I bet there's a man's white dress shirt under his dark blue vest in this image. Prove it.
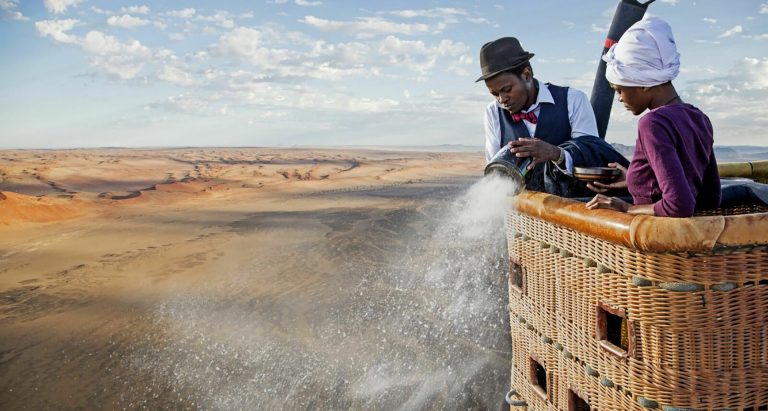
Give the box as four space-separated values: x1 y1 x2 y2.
485 82 598 174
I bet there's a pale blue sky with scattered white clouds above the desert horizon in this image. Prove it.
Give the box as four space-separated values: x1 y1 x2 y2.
0 0 768 149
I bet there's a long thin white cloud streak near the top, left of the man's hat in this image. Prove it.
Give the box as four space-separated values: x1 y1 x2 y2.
299 16 433 38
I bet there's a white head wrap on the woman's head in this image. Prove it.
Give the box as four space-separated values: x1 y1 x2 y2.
603 17 680 87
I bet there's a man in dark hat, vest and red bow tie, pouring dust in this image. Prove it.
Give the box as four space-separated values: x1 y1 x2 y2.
477 37 629 197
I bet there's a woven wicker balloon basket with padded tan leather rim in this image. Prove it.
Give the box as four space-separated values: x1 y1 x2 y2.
507 192 768 410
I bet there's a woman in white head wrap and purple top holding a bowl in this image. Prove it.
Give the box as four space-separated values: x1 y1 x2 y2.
587 17 720 217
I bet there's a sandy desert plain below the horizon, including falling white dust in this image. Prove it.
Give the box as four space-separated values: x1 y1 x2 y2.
0 148 509 409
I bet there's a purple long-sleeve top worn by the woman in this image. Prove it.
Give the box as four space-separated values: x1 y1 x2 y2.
627 104 720 217
